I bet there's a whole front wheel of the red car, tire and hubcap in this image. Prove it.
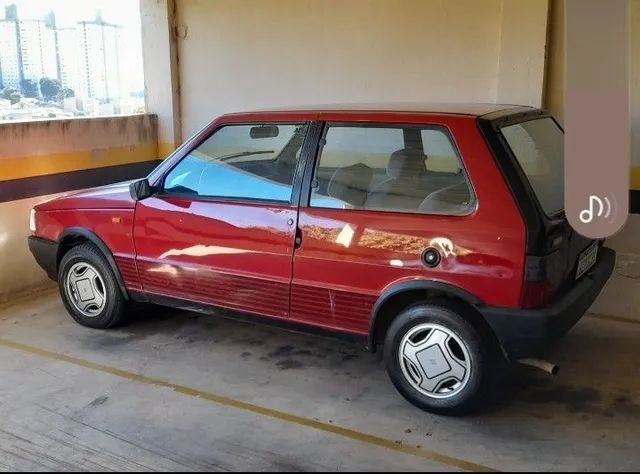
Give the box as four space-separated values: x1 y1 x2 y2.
58 244 126 329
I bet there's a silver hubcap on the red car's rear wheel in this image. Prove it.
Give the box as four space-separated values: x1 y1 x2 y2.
398 323 471 399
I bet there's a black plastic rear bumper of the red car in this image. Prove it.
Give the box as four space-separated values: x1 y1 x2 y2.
479 247 616 359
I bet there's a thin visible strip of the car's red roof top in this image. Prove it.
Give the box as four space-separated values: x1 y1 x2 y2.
244 102 535 117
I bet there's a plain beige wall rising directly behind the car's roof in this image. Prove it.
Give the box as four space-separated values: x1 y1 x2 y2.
175 0 547 137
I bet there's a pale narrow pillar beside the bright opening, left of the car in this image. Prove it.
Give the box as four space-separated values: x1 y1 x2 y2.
140 0 182 158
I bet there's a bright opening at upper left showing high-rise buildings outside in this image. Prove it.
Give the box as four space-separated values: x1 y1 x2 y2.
0 0 144 122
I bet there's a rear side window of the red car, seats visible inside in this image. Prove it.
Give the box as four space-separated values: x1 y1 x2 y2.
310 124 475 215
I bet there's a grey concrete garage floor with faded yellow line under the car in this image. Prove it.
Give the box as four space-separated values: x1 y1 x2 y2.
0 293 640 471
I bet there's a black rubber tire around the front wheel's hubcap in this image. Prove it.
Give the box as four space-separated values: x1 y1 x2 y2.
58 243 126 329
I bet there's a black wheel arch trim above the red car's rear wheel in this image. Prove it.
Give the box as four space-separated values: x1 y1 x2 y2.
367 280 484 352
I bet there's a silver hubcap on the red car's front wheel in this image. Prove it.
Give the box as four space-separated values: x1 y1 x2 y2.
65 262 107 318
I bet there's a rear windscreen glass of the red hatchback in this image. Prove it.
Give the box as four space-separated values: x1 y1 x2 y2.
501 117 564 216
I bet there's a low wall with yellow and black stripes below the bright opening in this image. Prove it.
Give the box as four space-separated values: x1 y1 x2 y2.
0 115 158 303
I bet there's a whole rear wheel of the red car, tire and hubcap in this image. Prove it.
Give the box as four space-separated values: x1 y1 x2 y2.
384 300 499 414
